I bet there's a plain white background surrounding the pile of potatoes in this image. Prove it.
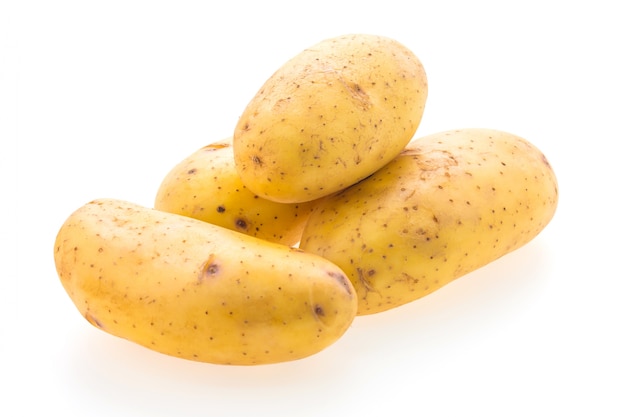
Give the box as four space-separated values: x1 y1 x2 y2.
0 0 626 417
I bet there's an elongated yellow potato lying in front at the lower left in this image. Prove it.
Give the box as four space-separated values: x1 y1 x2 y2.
54 199 357 365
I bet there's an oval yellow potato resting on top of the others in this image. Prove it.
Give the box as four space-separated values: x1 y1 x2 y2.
233 34 428 203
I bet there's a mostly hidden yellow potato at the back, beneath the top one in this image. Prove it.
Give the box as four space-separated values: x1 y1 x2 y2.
154 138 313 246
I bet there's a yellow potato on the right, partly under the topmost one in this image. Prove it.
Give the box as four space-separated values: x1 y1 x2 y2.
300 129 558 315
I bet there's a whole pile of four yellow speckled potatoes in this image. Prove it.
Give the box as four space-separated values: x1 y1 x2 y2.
54 34 558 365
